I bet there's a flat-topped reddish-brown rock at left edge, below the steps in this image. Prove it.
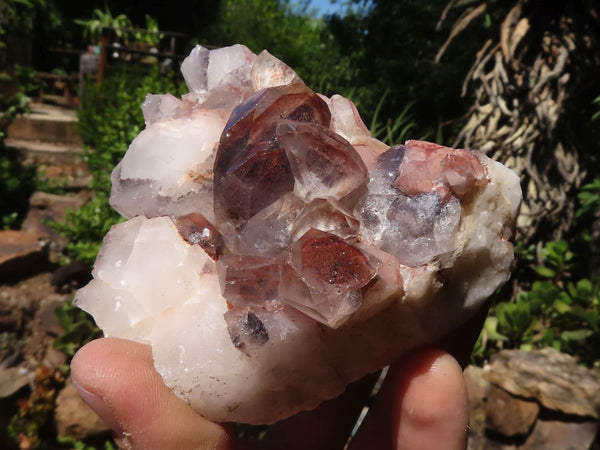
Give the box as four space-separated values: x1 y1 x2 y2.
0 230 48 278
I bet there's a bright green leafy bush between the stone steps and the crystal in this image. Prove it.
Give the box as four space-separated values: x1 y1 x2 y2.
52 68 183 264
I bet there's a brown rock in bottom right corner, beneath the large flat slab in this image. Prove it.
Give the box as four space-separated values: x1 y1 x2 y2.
518 420 598 450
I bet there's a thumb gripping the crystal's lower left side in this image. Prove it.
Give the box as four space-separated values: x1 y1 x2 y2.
71 338 234 450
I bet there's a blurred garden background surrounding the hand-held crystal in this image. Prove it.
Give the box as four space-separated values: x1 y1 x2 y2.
0 0 600 449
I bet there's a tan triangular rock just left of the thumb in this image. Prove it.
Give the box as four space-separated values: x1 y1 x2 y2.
54 379 110 440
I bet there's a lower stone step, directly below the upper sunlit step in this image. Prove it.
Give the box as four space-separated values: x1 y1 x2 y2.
4 139 91 189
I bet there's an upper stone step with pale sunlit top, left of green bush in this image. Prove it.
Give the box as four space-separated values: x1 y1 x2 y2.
7 103 81 145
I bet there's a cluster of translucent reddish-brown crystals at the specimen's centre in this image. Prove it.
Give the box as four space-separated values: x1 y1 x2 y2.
214 84 377 330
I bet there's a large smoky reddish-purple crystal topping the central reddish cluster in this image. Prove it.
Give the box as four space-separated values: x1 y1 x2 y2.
214 84 340 223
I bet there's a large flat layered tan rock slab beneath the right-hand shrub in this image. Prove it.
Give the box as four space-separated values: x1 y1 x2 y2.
487 348 600 419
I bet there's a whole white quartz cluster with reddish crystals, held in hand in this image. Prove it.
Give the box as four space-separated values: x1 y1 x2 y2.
75 45 521 424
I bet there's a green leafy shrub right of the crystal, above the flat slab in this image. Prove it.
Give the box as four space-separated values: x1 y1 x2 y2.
473 179 600 366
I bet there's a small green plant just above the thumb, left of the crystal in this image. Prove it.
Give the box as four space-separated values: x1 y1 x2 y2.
54 301 100 359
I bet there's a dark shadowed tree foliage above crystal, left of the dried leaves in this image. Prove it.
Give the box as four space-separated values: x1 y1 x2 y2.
327 0 486 137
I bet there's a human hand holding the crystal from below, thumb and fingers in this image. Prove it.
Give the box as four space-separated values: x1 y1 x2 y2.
71 338 468 450
